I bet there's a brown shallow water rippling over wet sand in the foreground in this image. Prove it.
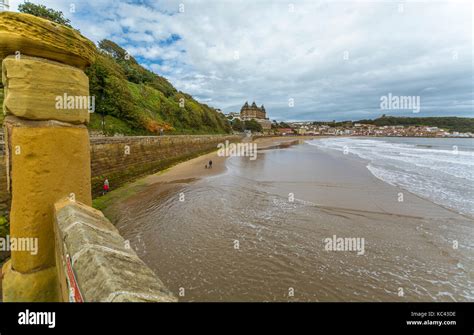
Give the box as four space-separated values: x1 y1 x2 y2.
116 144 474 301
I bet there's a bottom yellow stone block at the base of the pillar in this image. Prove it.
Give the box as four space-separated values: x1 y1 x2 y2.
2 261 59 302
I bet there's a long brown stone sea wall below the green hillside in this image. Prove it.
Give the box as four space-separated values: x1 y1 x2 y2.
0 135 241 215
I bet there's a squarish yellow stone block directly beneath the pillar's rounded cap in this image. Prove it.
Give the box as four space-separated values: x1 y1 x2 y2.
2 56 92 123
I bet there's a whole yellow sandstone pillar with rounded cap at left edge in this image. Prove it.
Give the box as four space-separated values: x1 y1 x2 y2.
0 12 94 301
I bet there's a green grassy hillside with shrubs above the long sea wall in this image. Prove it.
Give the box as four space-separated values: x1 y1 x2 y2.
86 40 231 135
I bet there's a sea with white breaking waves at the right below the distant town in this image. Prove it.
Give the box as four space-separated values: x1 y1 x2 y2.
307 137 474 217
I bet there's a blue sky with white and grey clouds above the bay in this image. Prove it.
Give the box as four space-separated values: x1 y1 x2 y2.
10 0 474 120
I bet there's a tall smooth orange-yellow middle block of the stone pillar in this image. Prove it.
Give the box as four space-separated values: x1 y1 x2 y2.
4 116 92 272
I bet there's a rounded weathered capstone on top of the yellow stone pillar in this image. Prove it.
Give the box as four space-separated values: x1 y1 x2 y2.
0 12 96 69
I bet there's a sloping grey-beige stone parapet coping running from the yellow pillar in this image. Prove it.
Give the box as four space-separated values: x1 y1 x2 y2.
54 199 177 302
